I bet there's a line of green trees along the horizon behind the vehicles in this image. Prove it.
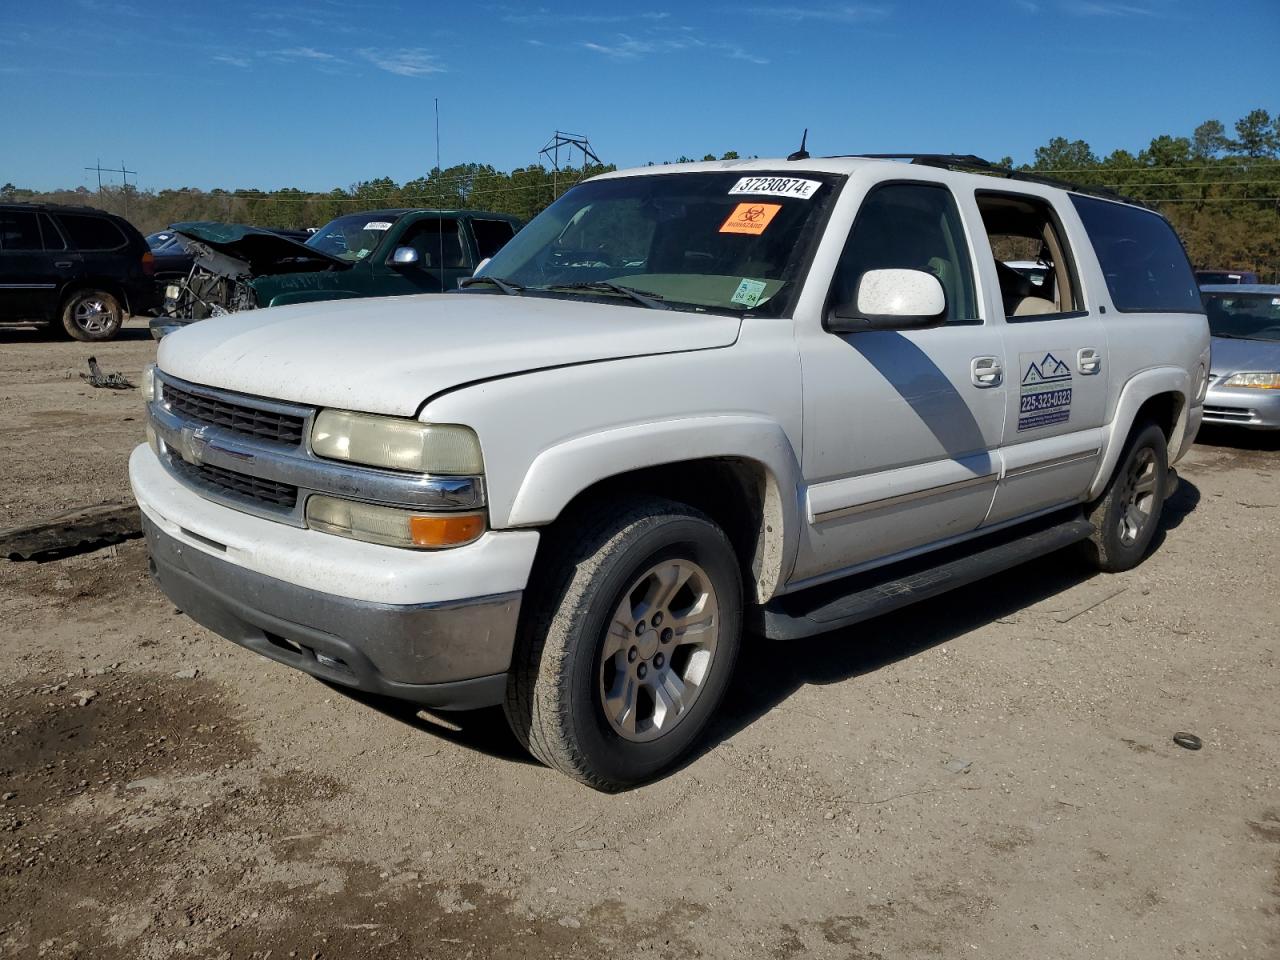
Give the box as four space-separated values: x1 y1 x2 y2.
0 109 1280 282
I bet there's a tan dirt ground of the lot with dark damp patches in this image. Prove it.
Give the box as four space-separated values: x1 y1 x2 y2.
0 324 1280 960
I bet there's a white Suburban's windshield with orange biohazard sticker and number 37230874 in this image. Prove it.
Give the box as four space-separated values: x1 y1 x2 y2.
470 173 842 316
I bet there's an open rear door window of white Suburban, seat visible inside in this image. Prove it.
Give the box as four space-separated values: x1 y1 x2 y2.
975 192 1084 321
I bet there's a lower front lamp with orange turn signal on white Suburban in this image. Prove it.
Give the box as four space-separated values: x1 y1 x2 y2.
307 495 485 549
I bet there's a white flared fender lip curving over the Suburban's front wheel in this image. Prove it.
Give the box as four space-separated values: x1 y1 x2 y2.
502 416 801 599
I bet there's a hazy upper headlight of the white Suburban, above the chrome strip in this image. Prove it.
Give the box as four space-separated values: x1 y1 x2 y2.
311 410 484 476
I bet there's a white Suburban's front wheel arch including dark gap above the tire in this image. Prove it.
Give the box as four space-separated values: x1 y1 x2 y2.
506 417 800 603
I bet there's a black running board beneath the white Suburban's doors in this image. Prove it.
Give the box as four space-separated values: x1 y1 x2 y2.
758 509 1093 640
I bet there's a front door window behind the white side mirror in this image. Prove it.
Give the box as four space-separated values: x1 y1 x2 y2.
836 183 978 323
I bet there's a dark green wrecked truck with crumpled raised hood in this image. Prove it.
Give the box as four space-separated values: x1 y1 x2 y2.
151 209 521 340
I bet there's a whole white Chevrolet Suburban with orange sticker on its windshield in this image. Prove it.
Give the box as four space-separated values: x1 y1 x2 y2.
129 155 1210 790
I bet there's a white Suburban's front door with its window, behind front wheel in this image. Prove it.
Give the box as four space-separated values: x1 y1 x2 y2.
792 182 1006 581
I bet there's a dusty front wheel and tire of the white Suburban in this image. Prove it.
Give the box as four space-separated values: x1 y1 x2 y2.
504 498 742 791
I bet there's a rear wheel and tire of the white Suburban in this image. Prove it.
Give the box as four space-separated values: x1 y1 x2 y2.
1083 422 1169 573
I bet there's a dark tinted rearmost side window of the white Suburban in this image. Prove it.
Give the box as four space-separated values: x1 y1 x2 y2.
1071 193 1204 314
